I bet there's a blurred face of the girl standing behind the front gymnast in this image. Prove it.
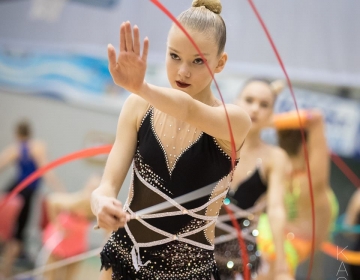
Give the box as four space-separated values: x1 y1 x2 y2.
237 81 274 130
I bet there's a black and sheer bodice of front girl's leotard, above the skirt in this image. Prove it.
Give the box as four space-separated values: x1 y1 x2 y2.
128 108 235 245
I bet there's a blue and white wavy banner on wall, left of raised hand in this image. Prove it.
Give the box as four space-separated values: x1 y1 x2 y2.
0 50 128 112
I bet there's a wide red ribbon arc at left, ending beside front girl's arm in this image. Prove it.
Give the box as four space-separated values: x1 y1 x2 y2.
0 145 112 211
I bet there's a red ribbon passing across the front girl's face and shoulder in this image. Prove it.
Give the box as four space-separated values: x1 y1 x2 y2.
150 0 250 280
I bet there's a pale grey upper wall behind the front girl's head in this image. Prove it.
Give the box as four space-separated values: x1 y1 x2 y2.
0 0 360 86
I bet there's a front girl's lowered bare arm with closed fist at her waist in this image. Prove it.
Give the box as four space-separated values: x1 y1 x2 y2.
91 95 148 231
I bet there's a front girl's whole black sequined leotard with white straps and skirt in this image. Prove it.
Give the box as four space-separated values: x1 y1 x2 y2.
100 107 238 279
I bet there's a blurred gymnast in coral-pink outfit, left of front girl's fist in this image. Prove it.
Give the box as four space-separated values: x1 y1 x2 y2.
43 175 101 280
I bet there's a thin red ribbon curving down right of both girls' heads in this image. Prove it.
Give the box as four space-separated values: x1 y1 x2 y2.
248 0 315 279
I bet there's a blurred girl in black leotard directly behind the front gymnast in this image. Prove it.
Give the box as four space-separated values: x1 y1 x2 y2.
215 79 293 280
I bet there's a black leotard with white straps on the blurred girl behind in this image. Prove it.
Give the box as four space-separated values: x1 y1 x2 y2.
215 168 267 280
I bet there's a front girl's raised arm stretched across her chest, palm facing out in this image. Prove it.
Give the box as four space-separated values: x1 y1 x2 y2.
108 22 251 148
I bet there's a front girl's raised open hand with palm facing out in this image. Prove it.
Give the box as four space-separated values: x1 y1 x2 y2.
108 21 149 94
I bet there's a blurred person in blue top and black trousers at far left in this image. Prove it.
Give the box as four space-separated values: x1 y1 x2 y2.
0 120 64 277
